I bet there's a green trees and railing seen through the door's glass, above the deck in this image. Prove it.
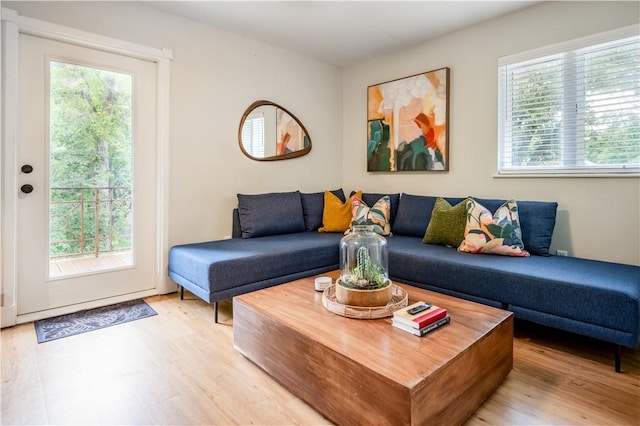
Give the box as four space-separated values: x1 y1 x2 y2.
49 61 132 256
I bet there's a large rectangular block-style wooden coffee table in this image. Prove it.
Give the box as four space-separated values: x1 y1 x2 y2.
233 271 513 425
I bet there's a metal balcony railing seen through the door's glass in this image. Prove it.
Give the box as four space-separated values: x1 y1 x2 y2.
49 187 133 259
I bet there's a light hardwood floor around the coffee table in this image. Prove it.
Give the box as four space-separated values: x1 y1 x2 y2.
0 293 640 425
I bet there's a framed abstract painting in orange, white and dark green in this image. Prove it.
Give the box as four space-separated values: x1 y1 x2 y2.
367 67 450 172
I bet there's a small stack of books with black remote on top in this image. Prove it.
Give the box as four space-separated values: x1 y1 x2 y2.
391 302 451 336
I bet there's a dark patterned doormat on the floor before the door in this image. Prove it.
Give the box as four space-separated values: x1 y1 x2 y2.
34 299 158 343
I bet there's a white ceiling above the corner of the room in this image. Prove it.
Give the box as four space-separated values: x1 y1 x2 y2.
148 0 540 67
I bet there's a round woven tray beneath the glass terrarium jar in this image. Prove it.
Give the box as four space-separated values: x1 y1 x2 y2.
322 284 409 319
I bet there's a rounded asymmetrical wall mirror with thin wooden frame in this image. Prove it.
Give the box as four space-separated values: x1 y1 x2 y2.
238 101 311 161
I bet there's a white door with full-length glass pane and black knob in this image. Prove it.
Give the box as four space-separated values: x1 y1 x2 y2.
16 34 157 317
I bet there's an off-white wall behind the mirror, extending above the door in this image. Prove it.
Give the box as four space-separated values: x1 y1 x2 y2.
3 2 342 245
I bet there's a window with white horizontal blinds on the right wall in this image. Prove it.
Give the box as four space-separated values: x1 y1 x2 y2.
498 26 640 175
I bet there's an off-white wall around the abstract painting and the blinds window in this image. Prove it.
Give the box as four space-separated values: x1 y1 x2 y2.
342 2 640 265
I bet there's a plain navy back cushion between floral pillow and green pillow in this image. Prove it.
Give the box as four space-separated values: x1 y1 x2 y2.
391 194 437 238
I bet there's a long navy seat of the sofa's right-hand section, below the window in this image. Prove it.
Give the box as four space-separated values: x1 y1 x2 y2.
387 236 640 347
